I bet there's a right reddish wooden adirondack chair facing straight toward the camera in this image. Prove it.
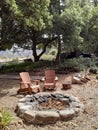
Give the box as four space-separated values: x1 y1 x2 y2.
42 70 58 90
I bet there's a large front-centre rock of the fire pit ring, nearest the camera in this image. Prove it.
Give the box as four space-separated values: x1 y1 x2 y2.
35 111 60 124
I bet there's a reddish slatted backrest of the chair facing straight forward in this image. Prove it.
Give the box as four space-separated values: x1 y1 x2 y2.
45 70 55 83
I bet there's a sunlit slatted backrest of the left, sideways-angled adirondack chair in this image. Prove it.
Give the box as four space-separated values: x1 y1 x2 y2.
20 72 31 87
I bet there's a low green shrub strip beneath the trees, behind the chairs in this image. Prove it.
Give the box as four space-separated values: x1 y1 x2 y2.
0 55 98 73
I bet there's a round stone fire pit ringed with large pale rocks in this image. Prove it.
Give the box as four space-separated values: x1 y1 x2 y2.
15 93 84 124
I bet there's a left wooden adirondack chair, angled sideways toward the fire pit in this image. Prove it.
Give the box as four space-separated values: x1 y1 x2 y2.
17 72 40 94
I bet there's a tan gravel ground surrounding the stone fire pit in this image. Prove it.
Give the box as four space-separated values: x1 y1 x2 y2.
0 74 98 130
